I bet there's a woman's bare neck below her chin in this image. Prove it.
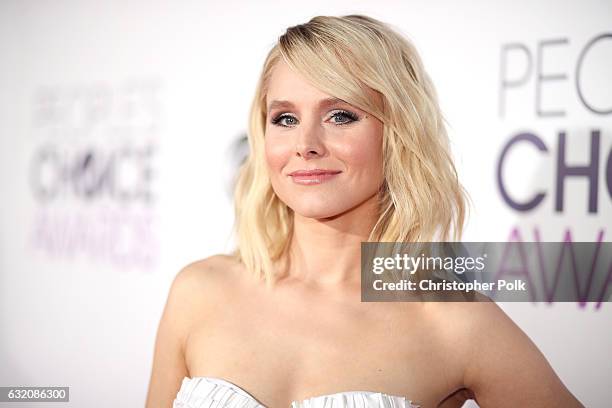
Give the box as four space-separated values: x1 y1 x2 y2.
280 195 378 288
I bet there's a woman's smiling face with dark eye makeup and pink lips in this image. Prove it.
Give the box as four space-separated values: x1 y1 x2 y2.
265 61 383 219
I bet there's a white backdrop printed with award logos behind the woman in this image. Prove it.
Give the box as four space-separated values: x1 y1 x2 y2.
0 0 612 407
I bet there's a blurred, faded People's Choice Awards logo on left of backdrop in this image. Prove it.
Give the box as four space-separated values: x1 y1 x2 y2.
27 78 162 271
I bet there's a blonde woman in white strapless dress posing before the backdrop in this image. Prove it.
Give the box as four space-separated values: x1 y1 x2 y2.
147 15 581 408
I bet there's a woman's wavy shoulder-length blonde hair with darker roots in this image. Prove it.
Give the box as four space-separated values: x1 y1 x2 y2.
232 15 468 283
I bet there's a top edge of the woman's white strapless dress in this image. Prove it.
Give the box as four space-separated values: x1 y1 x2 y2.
172 377 420 408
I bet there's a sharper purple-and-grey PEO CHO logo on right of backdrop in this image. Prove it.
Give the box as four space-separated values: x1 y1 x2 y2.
496 32 612 306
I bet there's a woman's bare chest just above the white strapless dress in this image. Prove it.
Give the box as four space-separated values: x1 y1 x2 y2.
185 304 461 407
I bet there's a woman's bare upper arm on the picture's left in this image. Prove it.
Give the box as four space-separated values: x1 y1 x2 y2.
146 264 207 408
